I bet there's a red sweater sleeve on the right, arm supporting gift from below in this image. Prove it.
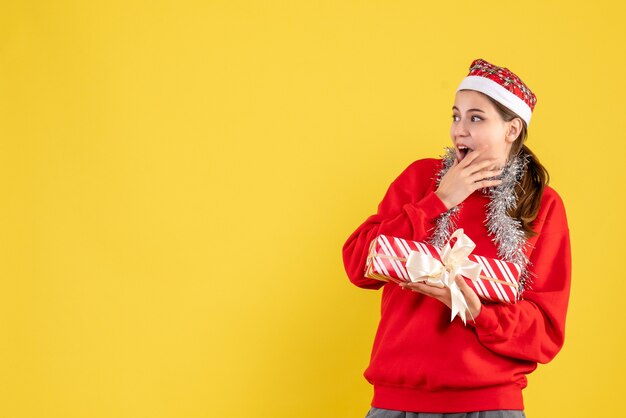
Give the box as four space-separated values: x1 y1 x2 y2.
468 191 571 363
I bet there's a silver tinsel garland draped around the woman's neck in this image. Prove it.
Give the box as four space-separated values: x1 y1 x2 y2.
429 148 530 296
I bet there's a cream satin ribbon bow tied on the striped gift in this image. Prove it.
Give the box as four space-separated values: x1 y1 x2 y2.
406 228 481 324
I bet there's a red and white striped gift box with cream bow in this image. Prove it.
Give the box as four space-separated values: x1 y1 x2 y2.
365 229 521 304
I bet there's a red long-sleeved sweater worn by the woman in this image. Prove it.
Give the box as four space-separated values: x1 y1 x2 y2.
343 159 571 413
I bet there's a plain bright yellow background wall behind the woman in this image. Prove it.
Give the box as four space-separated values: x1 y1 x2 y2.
0 0 626 418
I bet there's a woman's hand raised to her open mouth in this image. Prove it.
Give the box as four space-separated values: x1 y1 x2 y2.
435 151 502 209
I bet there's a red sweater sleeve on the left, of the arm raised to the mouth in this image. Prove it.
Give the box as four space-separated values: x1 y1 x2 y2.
342 159 447 289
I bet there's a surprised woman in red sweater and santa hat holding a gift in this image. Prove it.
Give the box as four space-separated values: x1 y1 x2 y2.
343 59 571 418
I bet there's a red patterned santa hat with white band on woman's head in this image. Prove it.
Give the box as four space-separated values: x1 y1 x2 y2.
457 59 537 126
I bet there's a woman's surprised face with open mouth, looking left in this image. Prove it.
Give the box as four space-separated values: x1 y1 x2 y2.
450 90 519 168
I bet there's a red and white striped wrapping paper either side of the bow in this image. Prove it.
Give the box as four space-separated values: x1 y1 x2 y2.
365 235 521 304
